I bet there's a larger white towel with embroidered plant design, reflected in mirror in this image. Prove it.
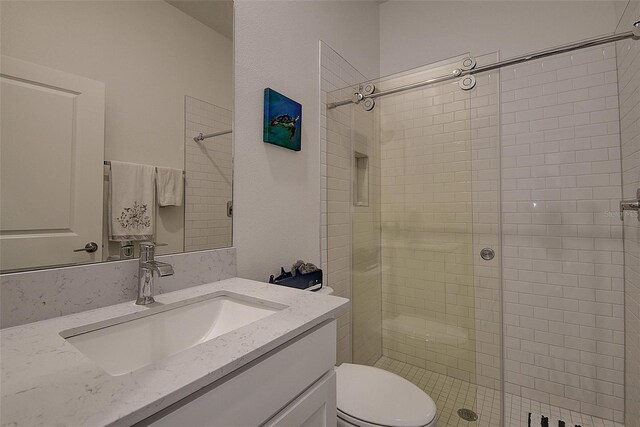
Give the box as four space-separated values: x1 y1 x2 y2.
109 161 156 241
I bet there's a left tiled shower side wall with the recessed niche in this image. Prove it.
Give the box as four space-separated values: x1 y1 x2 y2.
320 42 382 364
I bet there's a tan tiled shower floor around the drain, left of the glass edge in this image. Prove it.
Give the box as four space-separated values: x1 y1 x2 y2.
375 356 500 427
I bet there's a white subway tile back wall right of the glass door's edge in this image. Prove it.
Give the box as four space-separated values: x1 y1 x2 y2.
501 44 624 421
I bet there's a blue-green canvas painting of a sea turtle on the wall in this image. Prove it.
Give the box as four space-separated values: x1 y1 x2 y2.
263 88 302 151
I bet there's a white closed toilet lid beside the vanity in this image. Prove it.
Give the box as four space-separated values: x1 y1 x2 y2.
336 363 436 427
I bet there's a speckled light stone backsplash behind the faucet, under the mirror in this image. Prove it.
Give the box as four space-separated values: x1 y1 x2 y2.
0 248 236 328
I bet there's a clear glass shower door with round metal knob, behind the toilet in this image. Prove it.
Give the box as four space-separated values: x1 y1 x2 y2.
327 55 502 426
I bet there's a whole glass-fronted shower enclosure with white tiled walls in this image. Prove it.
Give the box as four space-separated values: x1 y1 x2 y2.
326 9 640 427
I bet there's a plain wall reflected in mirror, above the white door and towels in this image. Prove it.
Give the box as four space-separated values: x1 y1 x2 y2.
1 0 233 253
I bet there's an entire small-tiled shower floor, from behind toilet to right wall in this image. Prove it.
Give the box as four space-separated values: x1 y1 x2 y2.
375 356 624 427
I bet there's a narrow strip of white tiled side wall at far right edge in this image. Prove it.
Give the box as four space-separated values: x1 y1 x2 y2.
616 0 640 427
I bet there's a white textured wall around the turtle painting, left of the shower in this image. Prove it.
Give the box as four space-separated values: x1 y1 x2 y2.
233 0 379 280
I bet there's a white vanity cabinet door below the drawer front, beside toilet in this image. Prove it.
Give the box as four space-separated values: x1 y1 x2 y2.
266 370 338 427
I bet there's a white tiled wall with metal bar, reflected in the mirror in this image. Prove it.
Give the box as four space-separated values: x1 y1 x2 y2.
184 96 233 251
